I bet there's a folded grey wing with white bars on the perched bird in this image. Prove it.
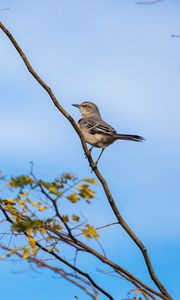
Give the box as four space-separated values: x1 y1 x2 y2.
79 117 116 136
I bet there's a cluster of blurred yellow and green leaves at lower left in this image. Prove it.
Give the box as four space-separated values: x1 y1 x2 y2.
0 172 99 259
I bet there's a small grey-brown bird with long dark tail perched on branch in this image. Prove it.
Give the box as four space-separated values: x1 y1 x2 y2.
72 101 145 165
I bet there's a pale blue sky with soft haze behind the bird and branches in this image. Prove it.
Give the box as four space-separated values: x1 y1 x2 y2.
0 0 180 300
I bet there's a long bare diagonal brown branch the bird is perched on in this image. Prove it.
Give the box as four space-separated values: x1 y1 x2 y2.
0 22 172 299
